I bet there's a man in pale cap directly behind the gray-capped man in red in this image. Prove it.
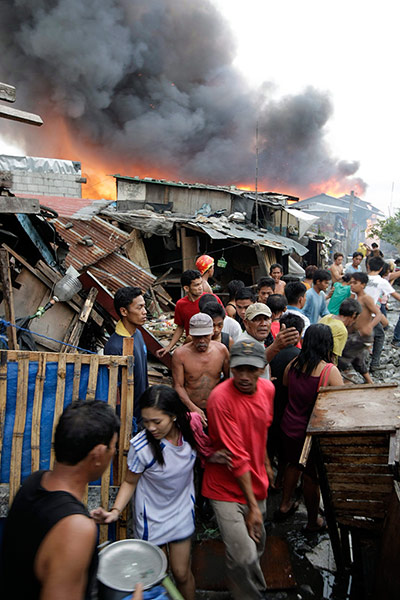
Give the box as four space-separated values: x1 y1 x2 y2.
238 302 299 379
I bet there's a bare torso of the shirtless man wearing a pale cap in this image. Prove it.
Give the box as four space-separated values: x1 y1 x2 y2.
172 341 229 422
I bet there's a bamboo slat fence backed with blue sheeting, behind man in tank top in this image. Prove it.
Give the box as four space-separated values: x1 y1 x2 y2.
0 350 134 542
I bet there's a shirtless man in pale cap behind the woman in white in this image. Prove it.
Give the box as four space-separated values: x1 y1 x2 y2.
172 313 229 426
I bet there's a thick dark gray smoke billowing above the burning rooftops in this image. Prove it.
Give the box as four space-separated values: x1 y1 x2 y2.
0 0 363 194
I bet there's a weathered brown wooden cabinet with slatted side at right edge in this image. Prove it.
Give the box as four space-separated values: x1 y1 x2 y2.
303 385 400 569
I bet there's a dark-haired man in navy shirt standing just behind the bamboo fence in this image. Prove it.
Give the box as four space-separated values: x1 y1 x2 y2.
104 287 149 433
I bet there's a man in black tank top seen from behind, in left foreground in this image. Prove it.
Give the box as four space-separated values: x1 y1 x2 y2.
0 401 142 600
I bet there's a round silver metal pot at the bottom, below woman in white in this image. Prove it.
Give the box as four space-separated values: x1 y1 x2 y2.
97 540 168 600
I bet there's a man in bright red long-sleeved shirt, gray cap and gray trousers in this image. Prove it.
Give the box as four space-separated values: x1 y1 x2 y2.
202 338 274 600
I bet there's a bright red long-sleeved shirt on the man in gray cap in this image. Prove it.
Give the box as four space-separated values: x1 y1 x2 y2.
202 378 275 504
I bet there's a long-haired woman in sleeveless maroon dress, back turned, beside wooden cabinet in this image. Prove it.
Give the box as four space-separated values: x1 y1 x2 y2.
275 324 343 532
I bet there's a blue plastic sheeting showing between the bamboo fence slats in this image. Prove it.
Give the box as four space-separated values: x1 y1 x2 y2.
0 362 108 483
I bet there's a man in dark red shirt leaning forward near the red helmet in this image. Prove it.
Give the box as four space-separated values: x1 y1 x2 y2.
156 269 222 358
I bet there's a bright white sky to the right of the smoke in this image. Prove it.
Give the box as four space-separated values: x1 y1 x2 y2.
215 0 400 214
